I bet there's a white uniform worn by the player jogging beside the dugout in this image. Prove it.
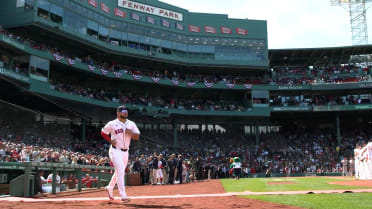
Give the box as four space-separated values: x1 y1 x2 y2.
102 119 140 199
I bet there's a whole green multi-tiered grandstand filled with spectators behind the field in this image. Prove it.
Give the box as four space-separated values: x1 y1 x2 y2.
0 0 372 197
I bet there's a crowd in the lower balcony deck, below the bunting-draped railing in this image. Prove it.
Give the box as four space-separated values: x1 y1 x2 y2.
51 77 372 112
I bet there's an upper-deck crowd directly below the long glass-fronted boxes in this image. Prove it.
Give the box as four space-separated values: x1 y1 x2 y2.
0 29 261 84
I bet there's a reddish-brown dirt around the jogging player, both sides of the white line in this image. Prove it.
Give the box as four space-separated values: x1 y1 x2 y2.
0 180 298 209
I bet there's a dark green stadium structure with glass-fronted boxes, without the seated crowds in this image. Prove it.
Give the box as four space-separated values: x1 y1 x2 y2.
0 0 372 145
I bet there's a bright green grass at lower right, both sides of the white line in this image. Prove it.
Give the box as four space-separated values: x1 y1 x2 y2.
221 177 372 209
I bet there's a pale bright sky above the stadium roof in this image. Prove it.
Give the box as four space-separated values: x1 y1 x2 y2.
160 0 372 49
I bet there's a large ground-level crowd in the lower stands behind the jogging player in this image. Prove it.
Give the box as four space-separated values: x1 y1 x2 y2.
0 117 372 184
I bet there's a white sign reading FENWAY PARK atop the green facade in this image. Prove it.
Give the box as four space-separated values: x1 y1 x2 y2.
118 0 183 21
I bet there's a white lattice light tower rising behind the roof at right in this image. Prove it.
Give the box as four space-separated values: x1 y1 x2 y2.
331 0 372 45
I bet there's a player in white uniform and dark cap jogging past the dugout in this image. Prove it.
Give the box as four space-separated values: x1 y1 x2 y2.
101 105 140 203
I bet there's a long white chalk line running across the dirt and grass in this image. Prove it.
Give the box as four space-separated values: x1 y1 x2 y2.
0 189 372 202
